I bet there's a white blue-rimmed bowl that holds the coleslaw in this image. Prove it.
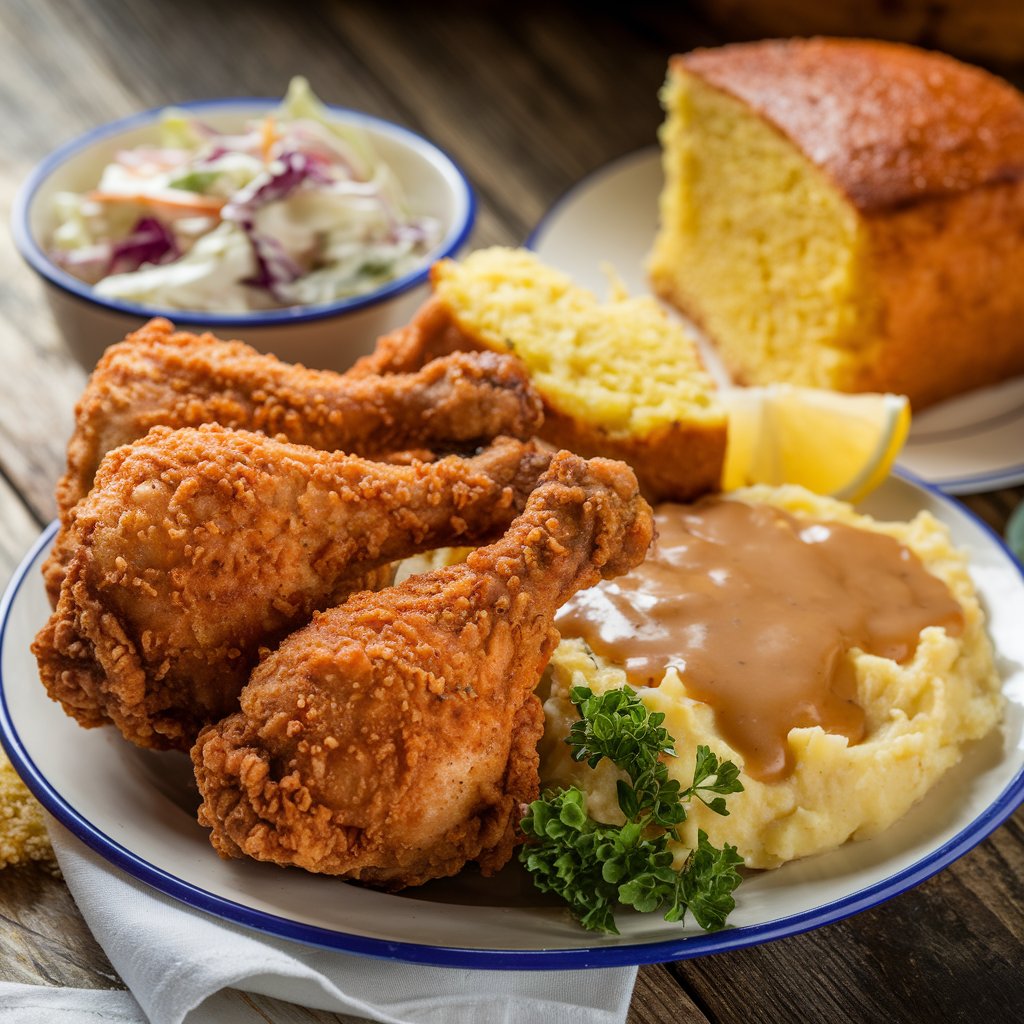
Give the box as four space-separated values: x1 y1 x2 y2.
11 97 476 370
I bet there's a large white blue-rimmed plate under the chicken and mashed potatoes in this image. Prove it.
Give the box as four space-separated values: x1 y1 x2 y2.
0 478 1024 969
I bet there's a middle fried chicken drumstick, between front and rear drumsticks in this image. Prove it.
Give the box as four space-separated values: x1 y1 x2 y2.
33 425 551 750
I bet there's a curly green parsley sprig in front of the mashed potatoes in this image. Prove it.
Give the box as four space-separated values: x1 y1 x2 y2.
519 686 743 935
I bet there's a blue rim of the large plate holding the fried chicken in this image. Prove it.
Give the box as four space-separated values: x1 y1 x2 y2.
0 472 1024 971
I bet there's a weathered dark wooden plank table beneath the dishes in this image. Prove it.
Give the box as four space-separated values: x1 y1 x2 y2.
0 0 1024 1024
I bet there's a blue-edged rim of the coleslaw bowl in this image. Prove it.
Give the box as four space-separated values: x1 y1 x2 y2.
11 96 477 328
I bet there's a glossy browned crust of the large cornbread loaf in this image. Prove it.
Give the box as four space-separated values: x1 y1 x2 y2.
659 39 1024 409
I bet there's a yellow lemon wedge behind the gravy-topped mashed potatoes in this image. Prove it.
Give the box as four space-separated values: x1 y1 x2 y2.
720 384 910 502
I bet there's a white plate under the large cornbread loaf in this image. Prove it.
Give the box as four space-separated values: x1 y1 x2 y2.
526 146 1024 495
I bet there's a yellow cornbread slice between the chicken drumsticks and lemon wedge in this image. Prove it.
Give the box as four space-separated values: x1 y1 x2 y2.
431 248 726 501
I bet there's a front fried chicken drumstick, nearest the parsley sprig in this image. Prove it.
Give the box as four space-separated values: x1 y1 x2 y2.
193 452 653 889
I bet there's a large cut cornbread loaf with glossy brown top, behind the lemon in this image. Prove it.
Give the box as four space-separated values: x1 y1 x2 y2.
649 39 1024 409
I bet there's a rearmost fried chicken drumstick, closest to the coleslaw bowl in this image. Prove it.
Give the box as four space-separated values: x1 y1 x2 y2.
43 319 541 604
